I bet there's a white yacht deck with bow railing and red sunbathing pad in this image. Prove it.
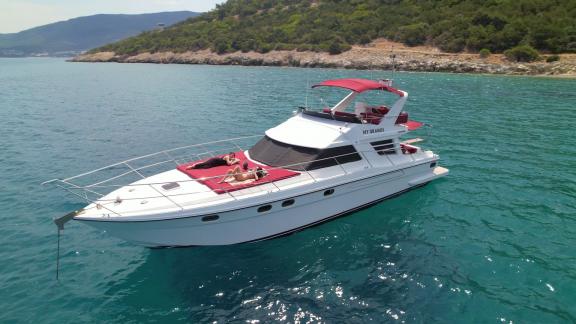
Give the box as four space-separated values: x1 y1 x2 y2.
49 134 434 220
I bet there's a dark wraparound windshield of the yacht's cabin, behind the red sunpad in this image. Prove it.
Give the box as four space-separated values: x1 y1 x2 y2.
249 136 362 171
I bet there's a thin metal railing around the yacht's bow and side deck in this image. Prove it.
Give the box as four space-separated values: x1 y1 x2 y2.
42 135 426 215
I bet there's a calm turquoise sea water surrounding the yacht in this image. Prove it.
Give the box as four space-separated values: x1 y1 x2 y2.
0 59 576 323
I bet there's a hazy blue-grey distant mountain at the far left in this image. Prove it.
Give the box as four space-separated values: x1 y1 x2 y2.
0 11 199 57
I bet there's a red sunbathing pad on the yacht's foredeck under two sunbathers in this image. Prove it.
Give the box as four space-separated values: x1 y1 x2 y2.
176 151 300 194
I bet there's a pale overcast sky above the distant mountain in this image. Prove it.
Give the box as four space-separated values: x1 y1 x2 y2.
0 0 226 33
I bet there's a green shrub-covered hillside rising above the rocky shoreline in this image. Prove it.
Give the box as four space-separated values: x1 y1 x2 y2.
93 0 576 55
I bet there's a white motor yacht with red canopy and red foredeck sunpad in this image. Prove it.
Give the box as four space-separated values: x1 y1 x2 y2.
45 79 448 247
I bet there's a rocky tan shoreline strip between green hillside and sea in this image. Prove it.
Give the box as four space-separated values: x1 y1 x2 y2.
70 40 576 78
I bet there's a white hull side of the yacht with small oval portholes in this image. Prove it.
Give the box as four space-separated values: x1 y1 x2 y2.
76 163 447 247
